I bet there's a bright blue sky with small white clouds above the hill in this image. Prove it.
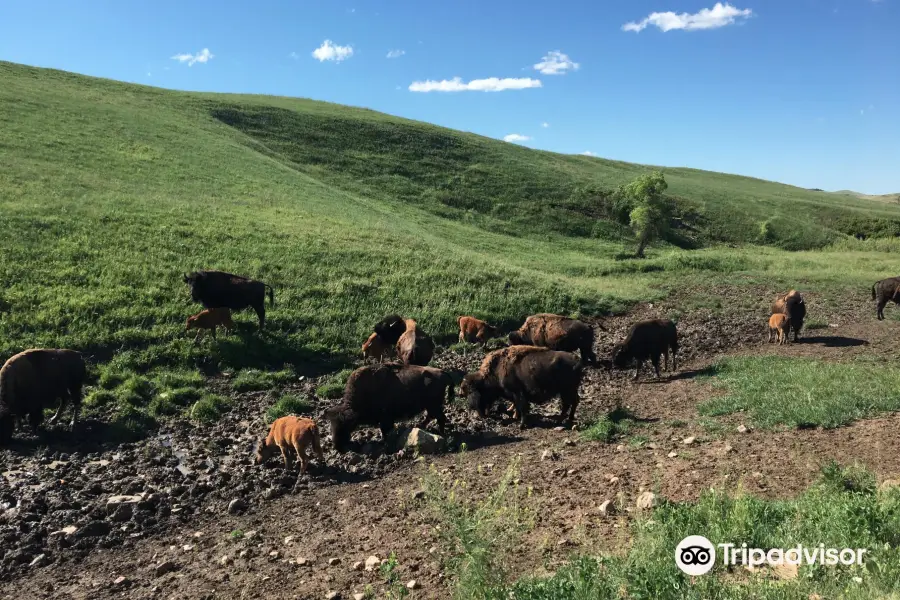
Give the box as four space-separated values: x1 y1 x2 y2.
0 0 900 194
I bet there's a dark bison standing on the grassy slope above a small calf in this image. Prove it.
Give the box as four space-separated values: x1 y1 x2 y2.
184 271 275 329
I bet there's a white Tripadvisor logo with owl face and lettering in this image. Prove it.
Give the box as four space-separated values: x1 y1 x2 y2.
675 535 867 576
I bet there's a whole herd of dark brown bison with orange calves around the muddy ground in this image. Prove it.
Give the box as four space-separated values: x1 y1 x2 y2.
0 271 900 471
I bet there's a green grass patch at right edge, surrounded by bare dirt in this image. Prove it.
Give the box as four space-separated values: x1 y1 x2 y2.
698 356 900 428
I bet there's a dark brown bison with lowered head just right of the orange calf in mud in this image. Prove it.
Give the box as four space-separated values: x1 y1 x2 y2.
324 363 453 452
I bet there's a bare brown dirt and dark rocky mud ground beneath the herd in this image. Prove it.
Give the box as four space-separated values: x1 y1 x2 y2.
0 290 900 600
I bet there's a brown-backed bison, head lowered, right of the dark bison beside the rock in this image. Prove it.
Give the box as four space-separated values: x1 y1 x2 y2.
460 346 583 429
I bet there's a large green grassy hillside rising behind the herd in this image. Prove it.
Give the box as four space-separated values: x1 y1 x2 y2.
0 63 900 426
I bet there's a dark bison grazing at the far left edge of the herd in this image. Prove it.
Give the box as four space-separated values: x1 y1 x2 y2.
0 348 87 444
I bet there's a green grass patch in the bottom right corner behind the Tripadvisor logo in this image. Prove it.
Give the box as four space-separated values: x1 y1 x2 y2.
448 464 900 600
